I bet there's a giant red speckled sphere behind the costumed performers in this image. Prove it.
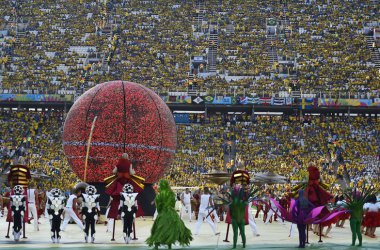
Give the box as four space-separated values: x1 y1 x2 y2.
63 81 177 183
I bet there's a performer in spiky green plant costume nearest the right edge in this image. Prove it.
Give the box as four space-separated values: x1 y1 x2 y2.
344 184 377 246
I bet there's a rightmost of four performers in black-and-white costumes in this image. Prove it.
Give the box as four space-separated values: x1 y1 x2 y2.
119 183 138 244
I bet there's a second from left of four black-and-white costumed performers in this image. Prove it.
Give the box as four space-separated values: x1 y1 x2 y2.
46 188 66 243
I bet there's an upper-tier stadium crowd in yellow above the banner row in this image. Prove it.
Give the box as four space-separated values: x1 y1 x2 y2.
0 0 380 96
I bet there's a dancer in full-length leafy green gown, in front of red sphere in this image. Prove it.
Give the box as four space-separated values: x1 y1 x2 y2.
146 180 193 249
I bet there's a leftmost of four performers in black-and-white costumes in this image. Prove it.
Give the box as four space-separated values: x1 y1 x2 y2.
10 185 26 241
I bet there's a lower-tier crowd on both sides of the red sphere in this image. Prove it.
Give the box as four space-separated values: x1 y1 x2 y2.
0 111 380 191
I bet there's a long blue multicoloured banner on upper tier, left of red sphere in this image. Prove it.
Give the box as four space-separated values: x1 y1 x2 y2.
0 94 74 102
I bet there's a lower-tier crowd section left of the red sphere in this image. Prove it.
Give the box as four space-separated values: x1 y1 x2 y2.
0 110 79 191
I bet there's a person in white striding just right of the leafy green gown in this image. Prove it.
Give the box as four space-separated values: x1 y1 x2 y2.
194 187 219 235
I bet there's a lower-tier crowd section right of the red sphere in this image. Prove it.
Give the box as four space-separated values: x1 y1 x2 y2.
169 115 380 192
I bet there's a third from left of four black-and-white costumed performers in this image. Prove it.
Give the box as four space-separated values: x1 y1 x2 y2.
82 185 100 243
